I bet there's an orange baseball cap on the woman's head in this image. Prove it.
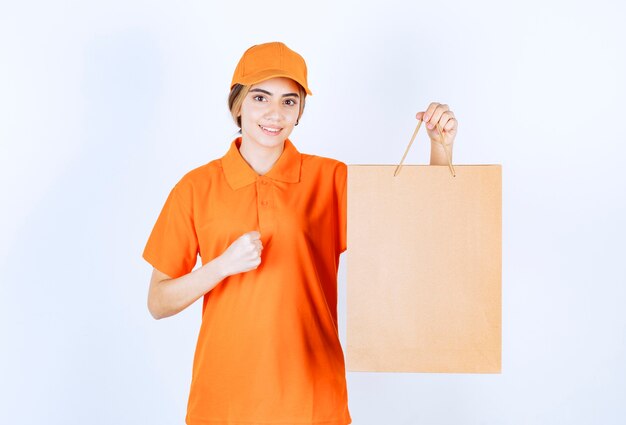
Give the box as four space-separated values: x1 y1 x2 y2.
230 41 313 95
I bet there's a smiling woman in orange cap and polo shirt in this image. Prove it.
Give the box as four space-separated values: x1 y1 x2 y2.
143 42 457 425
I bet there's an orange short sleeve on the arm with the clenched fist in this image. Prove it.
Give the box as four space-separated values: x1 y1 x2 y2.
143 182 198 278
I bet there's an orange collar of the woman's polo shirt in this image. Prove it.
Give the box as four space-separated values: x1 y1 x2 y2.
221 136 302 190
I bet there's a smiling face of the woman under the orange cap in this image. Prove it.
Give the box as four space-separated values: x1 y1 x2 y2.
240 77 300 148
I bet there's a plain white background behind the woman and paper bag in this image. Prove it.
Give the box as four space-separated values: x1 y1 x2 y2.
0 0 626 425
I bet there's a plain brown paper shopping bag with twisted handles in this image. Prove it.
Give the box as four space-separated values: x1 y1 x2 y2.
346 121 502 373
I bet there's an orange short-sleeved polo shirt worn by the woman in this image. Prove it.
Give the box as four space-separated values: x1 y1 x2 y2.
143 137 352 425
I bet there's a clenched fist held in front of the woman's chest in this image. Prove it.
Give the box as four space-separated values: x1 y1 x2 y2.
220 230 263 277
